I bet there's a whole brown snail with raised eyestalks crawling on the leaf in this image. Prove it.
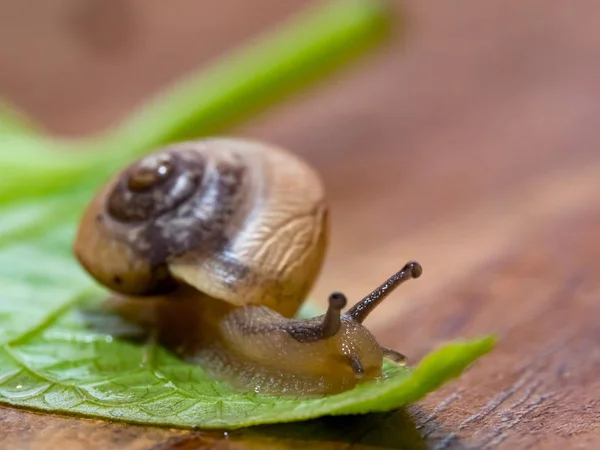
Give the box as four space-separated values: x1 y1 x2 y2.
74 139 422 395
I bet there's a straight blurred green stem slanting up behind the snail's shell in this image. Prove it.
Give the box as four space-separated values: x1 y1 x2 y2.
88 0 389 164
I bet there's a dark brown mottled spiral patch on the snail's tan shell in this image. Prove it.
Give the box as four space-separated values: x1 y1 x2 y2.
105 146 250 267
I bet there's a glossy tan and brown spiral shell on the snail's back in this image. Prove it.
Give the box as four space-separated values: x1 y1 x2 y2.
74 139 328 316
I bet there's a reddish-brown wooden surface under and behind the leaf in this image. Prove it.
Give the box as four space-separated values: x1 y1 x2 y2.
0 0 600 450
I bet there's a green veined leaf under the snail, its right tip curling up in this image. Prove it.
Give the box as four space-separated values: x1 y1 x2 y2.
0 227 493 428
